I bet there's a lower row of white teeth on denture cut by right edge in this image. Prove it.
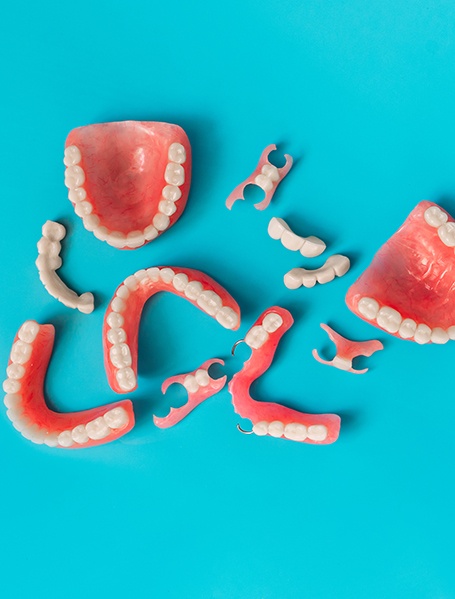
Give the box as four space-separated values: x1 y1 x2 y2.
357 297 455 345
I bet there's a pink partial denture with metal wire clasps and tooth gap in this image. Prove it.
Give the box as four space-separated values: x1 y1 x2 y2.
228 306 341 445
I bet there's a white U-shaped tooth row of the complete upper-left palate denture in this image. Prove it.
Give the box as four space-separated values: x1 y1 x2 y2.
63 143 186 249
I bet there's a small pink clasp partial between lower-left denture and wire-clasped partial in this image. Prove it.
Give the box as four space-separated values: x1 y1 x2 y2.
153 359 227 428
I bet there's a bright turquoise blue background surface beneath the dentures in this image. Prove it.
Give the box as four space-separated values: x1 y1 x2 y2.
0 0 455 599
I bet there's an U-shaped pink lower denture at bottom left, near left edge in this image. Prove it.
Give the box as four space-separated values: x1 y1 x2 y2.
3 320 134 449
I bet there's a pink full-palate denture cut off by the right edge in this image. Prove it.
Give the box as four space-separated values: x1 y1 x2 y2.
346 201 455 344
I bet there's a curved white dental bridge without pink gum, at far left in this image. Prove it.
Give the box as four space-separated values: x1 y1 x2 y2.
35 220 95 314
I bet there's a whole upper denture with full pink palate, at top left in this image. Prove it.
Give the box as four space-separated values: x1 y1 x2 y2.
64 121 191 249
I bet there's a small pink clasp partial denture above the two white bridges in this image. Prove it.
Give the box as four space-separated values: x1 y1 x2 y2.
226 144 292 210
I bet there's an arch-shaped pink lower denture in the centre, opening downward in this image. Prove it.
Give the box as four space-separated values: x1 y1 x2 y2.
103 266 240 393
